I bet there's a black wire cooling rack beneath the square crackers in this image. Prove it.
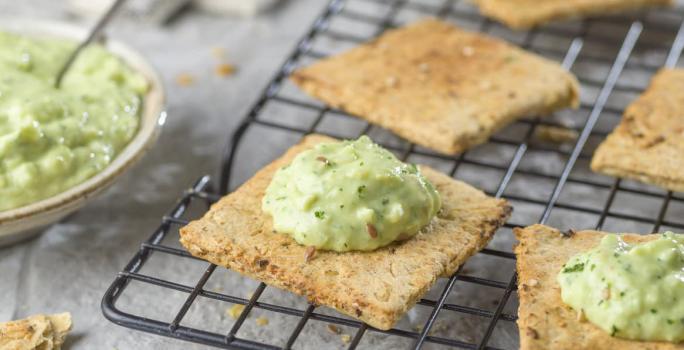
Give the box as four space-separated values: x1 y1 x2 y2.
102 0 684 349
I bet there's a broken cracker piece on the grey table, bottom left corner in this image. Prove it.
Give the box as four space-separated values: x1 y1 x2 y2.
0 312 71 350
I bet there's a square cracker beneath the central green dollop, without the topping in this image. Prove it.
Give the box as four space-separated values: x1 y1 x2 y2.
180 135 511 329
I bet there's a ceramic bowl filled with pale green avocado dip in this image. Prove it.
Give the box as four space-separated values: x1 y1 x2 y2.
0 20 166 246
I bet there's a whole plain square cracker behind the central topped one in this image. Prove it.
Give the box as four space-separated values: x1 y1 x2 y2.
291 19 579 154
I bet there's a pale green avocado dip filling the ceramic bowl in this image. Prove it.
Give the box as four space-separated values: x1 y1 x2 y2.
0 32 147 211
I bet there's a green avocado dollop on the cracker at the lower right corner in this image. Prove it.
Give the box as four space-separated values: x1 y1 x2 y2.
557 232 684 342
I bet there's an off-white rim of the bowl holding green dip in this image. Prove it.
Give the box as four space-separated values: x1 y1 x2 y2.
0 18 167 225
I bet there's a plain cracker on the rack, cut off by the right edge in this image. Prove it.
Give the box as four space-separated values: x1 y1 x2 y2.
591 69 684 191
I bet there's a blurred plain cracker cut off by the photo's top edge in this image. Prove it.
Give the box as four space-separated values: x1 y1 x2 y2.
474 0 672 29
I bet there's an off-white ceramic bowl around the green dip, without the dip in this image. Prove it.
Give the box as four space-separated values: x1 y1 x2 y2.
0 19 166 247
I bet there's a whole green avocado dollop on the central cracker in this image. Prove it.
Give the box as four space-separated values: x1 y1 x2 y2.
262 136 441 252
